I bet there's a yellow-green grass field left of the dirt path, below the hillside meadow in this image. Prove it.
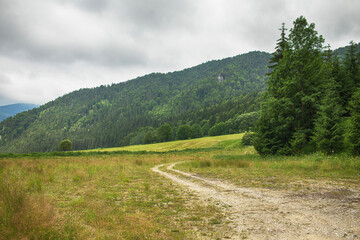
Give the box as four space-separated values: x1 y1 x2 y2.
0 155 228 239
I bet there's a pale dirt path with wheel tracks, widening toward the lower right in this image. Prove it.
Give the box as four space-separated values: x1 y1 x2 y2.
152 163 360 239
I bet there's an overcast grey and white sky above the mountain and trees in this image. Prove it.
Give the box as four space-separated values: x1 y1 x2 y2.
0 0 360 105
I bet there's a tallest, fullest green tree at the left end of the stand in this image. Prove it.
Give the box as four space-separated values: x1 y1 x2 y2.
254 16 324 154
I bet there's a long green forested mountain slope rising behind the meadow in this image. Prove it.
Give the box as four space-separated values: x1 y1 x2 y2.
0 52 271 152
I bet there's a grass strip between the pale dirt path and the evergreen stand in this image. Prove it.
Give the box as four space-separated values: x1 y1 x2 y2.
176 150 360 190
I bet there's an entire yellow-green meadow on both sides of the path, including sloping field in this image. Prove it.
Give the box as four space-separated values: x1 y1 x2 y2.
0 134 360 239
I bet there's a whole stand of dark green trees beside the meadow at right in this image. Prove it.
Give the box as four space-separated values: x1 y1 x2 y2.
254 17 360 155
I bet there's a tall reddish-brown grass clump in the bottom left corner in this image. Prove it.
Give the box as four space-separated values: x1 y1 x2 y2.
0 179 66 239
